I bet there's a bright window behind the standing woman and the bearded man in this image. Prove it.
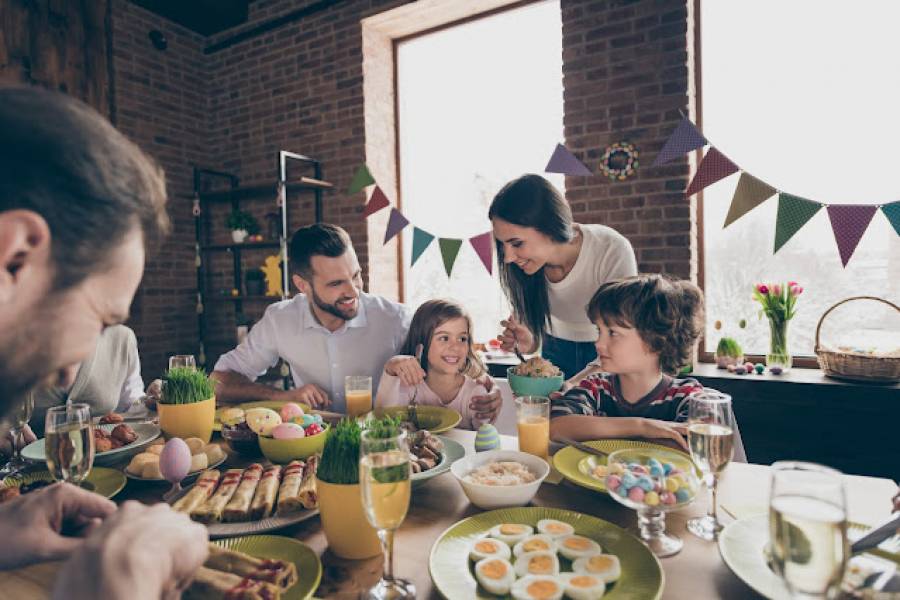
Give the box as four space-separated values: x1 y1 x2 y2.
397 0 563 342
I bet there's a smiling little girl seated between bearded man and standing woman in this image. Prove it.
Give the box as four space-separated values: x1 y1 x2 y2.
375 300 490 429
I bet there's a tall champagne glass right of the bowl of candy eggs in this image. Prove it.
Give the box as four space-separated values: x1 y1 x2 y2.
687 390 734 541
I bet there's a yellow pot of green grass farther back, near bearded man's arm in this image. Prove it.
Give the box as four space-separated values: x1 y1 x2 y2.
157 367 216 442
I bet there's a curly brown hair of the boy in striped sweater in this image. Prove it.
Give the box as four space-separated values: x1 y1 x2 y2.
587 275 703 374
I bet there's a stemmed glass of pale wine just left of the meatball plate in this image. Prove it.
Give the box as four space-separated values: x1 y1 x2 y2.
44 404 94 485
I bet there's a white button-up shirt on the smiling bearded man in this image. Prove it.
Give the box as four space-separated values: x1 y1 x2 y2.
215 293 412 412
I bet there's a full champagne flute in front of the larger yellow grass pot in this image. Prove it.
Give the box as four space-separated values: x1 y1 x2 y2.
359 431 416 600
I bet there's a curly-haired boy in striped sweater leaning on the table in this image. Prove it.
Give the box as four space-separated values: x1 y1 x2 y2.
550 275 703 449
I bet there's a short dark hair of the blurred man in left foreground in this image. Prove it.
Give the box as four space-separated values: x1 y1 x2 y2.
0 87 169 289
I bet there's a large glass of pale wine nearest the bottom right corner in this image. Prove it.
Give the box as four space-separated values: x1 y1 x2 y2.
769 461 850 598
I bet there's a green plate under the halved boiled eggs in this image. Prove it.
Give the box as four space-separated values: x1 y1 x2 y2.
429 507 665 600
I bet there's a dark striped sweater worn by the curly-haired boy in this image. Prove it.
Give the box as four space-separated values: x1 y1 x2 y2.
550 373 703 422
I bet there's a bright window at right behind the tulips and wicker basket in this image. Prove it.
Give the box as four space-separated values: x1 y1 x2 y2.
700 0 900 355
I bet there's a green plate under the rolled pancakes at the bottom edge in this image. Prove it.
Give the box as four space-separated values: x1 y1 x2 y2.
213 535 322 600
